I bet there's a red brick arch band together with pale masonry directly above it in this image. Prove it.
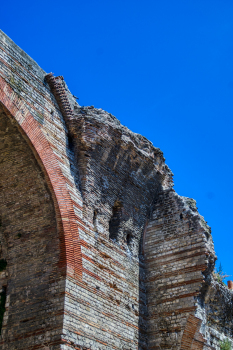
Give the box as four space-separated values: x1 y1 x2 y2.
0 32 82 282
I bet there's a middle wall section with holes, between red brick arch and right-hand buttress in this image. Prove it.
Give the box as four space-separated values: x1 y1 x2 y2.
46 74 172 349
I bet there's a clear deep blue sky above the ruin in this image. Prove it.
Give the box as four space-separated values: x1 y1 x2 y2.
1 0 233 278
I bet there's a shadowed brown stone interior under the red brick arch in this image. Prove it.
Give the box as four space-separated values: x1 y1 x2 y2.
0 106 64 349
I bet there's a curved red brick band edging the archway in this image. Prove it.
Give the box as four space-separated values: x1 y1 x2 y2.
0 77 82 279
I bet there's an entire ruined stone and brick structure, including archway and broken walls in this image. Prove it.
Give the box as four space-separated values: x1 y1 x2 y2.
0 31 233 350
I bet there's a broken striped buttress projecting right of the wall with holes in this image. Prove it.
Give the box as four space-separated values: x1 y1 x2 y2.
145 190 215 349
